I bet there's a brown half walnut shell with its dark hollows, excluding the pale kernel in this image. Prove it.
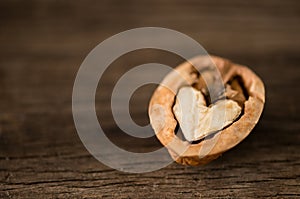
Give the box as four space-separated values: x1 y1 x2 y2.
148 56 265 166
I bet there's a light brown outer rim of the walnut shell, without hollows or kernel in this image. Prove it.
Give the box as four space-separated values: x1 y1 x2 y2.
148 56 265 166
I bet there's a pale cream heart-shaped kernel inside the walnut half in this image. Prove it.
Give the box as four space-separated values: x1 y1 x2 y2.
173 86 242 142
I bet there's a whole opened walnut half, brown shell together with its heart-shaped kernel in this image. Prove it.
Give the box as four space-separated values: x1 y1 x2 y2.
149 56 265 165
